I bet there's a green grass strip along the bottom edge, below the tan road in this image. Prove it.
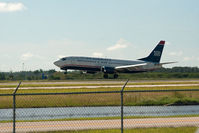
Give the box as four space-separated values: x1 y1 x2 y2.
36 127 197 133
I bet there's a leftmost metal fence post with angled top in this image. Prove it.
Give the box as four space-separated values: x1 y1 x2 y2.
13 81 21 133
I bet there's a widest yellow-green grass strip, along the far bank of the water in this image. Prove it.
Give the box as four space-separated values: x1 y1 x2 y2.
0 90 199 108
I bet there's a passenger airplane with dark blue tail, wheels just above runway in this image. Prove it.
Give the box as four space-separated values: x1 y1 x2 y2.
54 41 175 78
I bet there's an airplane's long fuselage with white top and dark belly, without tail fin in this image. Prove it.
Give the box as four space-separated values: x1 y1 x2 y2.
54 56 160 73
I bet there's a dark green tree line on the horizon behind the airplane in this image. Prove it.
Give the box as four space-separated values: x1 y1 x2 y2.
0 67 199 80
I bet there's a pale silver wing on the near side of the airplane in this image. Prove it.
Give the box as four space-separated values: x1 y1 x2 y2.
115 63 147 71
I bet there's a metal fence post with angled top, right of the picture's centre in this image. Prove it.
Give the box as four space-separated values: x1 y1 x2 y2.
120 79 129 133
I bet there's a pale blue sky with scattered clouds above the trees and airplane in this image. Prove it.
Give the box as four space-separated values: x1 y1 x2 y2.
0 0 199 72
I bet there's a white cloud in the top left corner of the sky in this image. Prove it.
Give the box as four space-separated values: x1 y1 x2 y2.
0 2 26 12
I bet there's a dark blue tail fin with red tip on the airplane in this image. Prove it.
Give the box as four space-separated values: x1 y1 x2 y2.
138 41 165 63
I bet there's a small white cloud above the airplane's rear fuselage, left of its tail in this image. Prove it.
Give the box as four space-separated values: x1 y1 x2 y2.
106 38 130 51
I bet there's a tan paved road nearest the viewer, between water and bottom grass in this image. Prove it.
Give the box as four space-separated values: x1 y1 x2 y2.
0 117 199 133
